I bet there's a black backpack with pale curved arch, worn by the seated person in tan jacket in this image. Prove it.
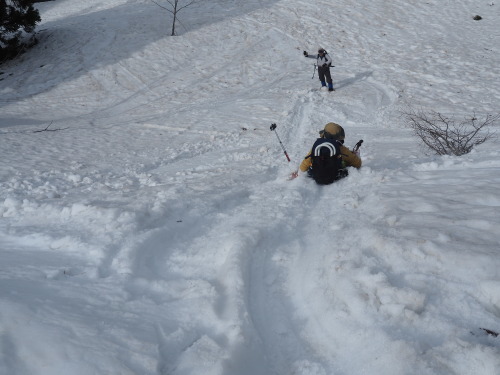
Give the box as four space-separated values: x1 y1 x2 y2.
309 138 343 185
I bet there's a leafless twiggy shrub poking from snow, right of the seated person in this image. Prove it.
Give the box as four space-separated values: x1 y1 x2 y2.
402 107 500 156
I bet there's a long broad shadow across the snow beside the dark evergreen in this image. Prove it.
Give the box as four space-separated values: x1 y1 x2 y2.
0 0 278 115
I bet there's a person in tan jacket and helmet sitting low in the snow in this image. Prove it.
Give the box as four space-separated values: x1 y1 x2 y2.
291 122 361 185
